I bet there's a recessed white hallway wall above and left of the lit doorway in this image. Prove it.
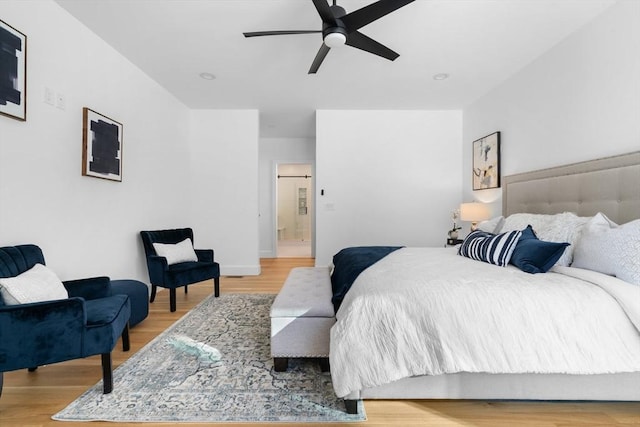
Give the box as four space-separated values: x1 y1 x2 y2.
259 138 315 258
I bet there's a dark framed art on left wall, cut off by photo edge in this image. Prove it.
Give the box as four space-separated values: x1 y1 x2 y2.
0 21 27 121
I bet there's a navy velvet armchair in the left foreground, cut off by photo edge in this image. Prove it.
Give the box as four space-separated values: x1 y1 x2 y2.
0 245 131 394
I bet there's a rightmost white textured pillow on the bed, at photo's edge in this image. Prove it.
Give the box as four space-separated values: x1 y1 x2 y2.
571 213 640 285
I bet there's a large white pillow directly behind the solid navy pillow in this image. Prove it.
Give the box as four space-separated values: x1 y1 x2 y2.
500 212 589 267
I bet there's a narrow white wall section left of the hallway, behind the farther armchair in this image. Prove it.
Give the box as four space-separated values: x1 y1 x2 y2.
190 110 260 275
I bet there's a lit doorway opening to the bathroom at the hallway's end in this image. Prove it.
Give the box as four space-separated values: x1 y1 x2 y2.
276 163 314 258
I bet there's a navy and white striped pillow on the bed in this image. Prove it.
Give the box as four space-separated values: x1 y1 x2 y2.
458 230 522 267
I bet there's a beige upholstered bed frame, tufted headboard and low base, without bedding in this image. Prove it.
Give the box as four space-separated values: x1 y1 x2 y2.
331 152 640 410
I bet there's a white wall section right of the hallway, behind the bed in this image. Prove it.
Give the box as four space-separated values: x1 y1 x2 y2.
316 110 462 265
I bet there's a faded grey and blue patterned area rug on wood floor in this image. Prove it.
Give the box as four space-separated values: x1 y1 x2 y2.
52 294 366 423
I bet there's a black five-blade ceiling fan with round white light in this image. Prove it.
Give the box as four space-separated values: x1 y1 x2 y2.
243 0 415 74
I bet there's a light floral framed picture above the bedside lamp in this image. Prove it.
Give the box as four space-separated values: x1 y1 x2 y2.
472 132 500 190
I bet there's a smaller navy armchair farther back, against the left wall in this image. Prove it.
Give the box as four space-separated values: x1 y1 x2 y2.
140 228 220 311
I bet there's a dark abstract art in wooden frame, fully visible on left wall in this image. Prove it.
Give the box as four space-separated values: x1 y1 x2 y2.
82 107 122 181
